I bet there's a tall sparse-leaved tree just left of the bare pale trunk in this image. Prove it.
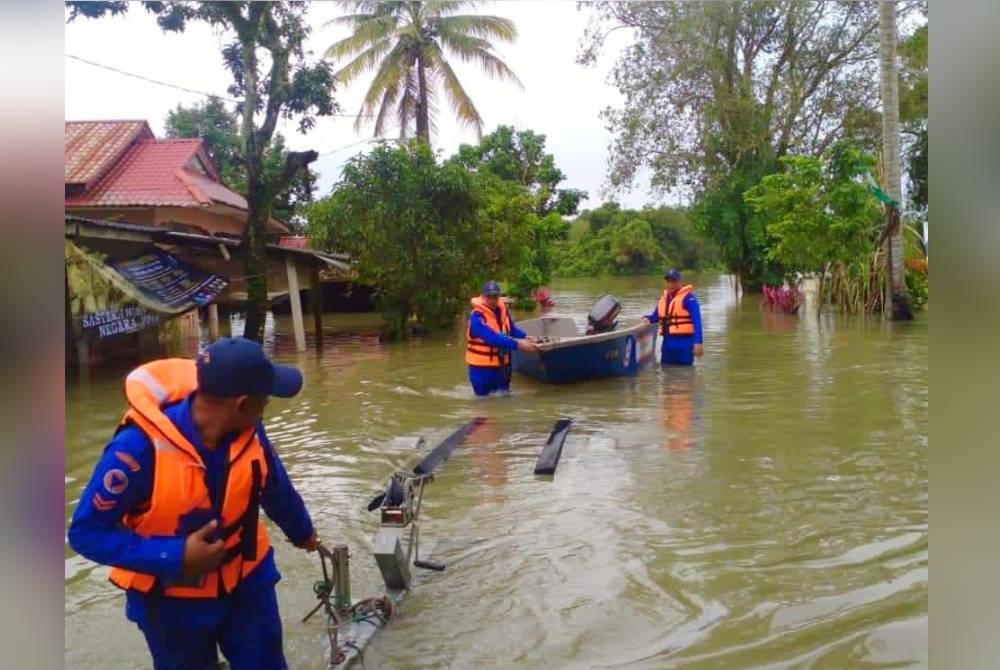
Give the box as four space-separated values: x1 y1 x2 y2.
580 0 924 286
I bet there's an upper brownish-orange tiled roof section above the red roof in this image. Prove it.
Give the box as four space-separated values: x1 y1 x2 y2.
65 121 154 185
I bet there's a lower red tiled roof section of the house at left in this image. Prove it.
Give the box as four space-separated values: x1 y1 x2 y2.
65 139 247 210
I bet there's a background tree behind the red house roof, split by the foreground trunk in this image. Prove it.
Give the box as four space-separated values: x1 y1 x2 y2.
165 96 319 230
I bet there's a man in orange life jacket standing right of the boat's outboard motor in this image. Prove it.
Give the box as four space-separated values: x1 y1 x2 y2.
642 269 702 365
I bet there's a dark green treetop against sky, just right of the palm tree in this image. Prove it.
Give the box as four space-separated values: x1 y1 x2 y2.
453 126 587 216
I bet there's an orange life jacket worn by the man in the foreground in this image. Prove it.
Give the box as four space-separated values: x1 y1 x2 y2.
108 358 270 598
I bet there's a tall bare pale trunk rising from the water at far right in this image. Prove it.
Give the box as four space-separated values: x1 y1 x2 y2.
879 0 913 320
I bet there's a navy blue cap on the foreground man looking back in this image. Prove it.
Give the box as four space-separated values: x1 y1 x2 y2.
197 337 302 398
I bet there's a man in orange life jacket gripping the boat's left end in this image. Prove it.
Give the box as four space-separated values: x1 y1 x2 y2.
465 281 538 396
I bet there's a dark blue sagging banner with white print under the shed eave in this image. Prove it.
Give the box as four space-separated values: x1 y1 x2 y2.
108 249 228 313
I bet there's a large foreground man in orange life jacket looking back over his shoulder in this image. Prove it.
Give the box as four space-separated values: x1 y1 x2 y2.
68 338 317 670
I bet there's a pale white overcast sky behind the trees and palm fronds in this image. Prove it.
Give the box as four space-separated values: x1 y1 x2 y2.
64 0 652 209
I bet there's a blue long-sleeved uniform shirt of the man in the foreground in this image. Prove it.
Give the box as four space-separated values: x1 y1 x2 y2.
68 394 313 607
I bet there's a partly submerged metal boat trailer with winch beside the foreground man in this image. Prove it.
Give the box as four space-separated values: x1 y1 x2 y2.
303 417 485 670
